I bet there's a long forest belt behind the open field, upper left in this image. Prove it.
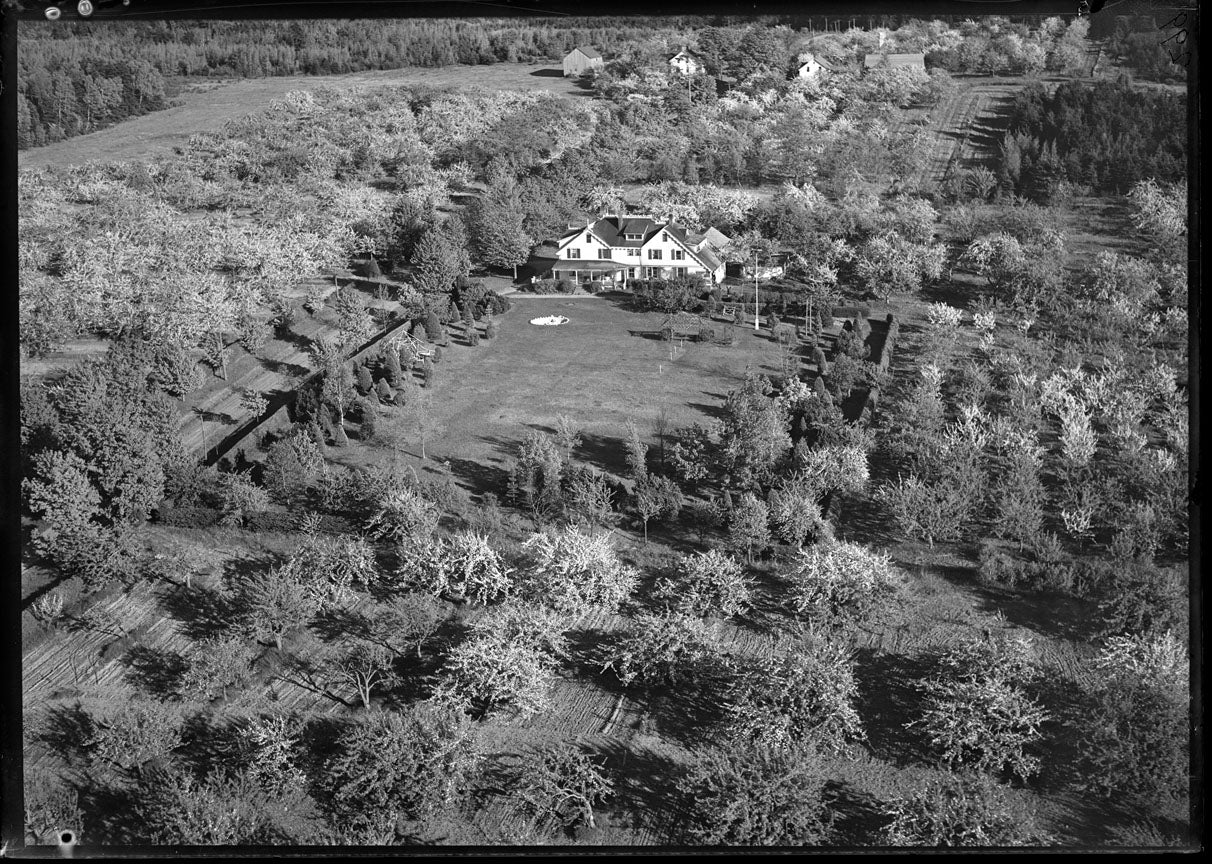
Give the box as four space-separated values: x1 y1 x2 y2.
17 18 692 149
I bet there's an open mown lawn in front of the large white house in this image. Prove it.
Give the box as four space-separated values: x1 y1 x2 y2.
330 294 779 494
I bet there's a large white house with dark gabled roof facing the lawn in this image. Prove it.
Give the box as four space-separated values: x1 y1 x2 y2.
551 214 728 287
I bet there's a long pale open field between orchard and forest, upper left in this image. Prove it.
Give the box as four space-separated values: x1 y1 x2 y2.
18 63 590 168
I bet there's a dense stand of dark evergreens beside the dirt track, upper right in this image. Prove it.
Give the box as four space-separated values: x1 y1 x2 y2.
1001 80 1187 199
